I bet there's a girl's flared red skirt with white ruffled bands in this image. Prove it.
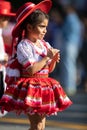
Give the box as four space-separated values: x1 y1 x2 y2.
0 78 72 115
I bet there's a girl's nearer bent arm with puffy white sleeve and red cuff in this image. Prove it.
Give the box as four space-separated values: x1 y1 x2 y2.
17 41 57 75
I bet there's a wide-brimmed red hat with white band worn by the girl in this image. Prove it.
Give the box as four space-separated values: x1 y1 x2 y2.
12 0 52 37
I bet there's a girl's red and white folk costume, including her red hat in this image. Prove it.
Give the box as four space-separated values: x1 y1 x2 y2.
0 0 72 116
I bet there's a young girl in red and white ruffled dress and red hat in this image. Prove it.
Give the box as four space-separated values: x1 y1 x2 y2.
0 0 72 130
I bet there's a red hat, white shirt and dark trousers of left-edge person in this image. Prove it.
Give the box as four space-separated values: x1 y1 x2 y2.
0 0 15 98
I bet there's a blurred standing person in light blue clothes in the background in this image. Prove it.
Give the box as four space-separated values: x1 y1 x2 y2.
60 4 84 95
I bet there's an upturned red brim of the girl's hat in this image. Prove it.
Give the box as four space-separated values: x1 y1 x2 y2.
12 0 52 37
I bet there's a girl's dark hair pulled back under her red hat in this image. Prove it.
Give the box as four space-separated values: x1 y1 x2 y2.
17 10 49 43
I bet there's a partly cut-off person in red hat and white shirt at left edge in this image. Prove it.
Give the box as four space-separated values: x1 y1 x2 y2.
0 0 15 117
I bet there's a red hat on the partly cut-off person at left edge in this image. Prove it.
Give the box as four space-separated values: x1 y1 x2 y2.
0 0 15 16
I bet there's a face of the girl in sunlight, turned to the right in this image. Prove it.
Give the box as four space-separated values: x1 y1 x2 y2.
28 19 48 42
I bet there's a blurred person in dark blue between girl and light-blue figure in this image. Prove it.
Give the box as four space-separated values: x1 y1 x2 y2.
45 2 65 80
